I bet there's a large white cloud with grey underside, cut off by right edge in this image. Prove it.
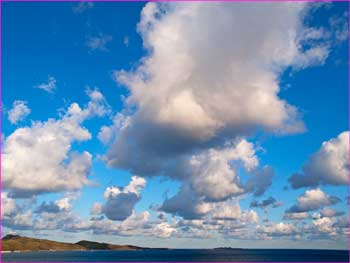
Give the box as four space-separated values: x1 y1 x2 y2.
289 131 349 188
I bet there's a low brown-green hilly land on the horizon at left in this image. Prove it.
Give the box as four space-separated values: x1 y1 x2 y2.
2 235 150 254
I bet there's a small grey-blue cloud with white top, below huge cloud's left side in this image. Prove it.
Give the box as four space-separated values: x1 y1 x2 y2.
92 176 146 221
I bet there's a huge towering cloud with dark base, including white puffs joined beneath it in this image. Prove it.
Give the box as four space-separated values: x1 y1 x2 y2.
99 3 328 221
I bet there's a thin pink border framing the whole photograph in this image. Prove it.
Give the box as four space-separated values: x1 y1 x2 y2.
0 0 350 263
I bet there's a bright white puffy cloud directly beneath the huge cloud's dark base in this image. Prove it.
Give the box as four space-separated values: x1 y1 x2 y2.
186 140 258 201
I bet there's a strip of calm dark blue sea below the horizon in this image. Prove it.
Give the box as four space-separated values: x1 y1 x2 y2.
2 249 349 262
